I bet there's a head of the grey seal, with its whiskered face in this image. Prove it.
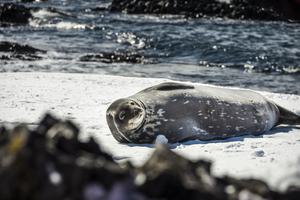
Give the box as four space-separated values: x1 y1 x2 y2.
106 98 146 143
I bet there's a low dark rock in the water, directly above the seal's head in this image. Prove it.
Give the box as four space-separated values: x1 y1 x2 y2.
80 52 148 63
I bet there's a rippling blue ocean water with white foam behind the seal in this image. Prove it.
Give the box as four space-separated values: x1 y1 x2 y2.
0 0 300 94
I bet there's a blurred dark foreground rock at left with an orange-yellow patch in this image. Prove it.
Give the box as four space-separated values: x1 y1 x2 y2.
0 115 130 200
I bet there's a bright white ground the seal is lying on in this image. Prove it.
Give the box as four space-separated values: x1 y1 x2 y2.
0 73 300 189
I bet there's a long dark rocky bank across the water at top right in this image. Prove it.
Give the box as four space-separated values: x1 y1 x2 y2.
111 0 300 20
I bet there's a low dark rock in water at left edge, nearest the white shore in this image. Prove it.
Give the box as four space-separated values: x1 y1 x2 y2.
0 41 46 60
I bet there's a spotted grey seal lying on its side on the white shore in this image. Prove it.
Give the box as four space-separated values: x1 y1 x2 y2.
106 82 300 143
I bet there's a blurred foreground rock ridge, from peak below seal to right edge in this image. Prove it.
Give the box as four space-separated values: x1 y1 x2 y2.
135 146 300 200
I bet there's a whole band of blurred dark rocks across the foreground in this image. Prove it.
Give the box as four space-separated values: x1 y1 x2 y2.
0 115 300 200
